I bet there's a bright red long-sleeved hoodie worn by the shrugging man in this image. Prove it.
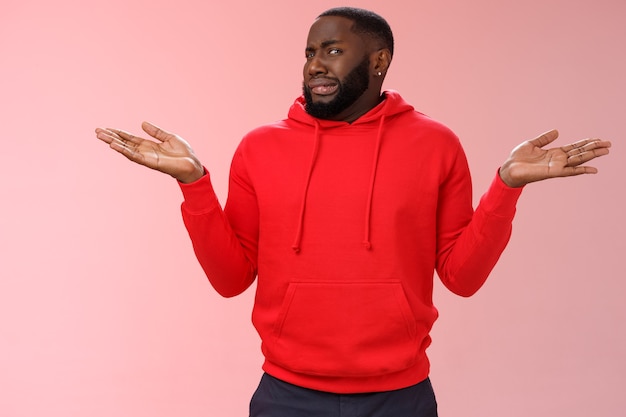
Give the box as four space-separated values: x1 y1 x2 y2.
181 91 521 393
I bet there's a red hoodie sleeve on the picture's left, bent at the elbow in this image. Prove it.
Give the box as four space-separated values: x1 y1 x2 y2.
180 148 258 297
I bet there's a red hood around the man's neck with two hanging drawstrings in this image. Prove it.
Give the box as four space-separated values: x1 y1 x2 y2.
288 90 414 253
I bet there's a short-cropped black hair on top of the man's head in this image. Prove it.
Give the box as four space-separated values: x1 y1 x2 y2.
318 7 393 57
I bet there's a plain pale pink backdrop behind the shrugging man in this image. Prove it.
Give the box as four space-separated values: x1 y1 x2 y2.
0 0 626 417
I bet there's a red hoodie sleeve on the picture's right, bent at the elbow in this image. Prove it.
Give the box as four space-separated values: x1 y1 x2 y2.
436 143 522 297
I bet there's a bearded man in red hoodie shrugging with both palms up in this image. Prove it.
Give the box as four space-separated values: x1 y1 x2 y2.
96 8 610 417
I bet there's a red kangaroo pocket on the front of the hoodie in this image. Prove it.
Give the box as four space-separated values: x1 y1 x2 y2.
265 281 426 377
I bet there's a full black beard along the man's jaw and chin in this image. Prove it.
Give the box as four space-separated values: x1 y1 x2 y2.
302 56 370 119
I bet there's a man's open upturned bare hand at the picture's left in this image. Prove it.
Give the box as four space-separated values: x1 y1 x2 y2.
96 122 204 183
